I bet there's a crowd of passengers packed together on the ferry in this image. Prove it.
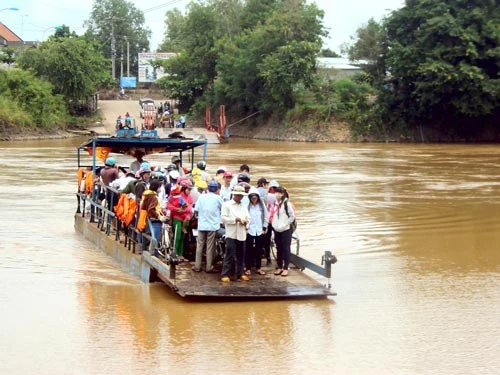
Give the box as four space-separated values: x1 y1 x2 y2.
79 151 295 283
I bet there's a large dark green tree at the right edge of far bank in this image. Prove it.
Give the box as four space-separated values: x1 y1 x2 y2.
384 0 500 133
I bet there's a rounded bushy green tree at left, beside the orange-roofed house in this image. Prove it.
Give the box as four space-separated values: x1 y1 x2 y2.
17 37 107 108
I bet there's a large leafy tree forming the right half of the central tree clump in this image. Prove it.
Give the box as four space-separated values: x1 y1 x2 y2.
214 0 326 113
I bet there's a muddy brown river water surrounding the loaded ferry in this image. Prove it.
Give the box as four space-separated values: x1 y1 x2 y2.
0 139 500 374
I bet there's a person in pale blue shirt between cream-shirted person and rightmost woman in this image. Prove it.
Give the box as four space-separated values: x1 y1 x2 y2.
245 188 269 276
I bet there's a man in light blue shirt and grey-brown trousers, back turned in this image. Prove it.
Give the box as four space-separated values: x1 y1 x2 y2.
193 181 224 273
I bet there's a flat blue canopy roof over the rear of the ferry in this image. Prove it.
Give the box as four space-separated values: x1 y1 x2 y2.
78 137 207 155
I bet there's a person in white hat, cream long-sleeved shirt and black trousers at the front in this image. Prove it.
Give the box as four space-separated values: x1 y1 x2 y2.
221 186 250 283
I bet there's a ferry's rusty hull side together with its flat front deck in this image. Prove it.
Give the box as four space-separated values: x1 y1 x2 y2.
75 214 335 300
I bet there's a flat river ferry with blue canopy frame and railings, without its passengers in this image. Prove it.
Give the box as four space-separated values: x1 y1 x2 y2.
74 133 337 300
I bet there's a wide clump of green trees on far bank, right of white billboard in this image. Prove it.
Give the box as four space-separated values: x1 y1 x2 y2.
161 0 326 114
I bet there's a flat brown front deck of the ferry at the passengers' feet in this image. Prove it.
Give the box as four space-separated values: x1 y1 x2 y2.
143 253 335 299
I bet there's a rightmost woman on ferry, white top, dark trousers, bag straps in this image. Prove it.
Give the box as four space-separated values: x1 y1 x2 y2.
272 186 295 276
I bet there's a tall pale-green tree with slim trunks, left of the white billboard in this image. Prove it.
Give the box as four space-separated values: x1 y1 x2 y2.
86 0 151 77
